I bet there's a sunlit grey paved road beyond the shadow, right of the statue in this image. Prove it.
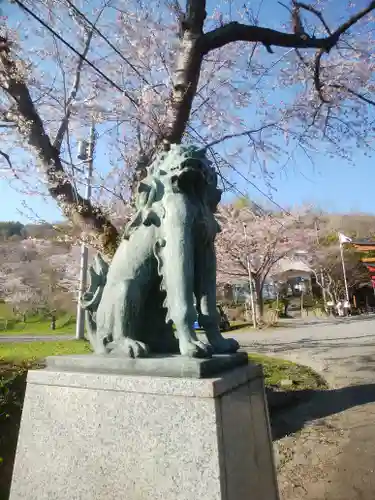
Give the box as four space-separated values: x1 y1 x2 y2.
228 317 375 386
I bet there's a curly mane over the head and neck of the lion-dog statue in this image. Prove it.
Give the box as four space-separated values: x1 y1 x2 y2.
123 144 217 239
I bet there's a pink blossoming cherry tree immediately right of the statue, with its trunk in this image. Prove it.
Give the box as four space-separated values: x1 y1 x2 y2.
216 205 316 317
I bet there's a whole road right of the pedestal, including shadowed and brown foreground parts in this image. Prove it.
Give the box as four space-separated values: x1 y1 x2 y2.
225 318 375 500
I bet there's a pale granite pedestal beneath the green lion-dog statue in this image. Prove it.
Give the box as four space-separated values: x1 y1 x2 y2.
10 353 279 500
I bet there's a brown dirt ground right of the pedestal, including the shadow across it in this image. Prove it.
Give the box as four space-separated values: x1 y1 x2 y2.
273 384 375 500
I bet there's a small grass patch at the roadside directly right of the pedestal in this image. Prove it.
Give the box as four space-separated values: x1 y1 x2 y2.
249 354 327 391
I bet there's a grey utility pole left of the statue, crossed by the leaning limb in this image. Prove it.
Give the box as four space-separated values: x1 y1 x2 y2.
76 121 95 340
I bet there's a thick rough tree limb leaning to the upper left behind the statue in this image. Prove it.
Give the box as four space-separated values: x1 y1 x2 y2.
0 38 118 255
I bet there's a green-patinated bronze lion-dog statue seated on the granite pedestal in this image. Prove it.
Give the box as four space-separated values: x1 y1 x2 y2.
82 145 239 358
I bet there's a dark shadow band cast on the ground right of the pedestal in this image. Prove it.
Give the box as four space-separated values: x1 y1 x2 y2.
270 384 375 440
